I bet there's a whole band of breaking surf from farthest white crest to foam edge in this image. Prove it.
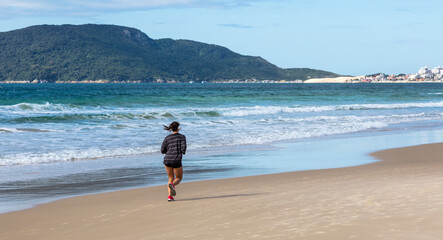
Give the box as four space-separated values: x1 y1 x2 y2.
0 96 443 165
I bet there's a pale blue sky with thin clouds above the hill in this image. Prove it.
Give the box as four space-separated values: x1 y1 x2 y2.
0 0 443 75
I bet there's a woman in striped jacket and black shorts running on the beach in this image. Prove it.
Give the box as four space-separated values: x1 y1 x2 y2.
161 122 186 201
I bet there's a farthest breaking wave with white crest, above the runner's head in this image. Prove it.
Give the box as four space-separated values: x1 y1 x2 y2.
0 101 443 122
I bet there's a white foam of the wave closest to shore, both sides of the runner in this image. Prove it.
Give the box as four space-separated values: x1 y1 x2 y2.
0 109 443 165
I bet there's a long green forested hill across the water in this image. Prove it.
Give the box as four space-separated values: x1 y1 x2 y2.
0 24 338 82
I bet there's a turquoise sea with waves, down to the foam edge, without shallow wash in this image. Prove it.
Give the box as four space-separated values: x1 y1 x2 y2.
0 84 443 166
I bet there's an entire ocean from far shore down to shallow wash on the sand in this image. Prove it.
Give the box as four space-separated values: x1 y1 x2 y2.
0 83 443 211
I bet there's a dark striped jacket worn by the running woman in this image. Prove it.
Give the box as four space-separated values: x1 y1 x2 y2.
161 133 186 162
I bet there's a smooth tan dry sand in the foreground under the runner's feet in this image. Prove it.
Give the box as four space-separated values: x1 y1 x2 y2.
0 143 443 240
